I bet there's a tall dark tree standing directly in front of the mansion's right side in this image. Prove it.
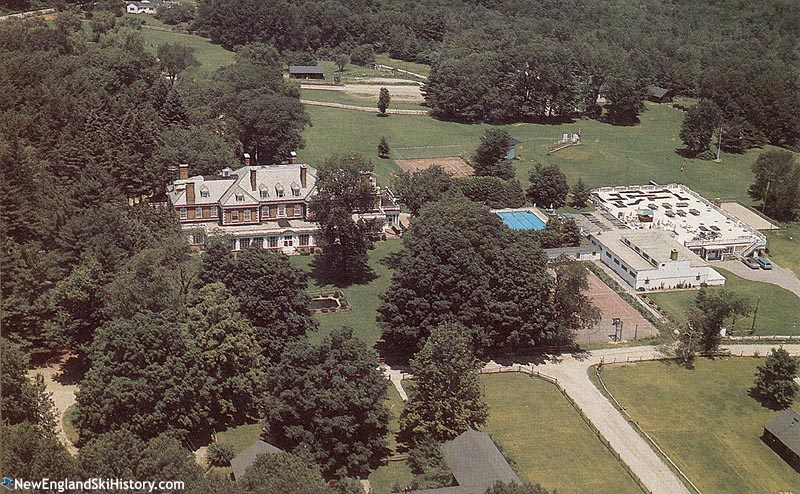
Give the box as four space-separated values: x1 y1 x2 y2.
311 155 377 283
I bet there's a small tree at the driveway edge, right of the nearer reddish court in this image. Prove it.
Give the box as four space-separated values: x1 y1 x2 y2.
687 288 752 352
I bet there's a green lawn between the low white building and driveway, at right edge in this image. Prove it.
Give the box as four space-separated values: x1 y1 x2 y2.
647 268 800 335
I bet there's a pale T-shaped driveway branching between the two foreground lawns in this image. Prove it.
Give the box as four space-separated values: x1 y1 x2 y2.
487 345 800 494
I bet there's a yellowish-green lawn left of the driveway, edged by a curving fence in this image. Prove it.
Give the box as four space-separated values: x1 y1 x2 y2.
481 374 641 494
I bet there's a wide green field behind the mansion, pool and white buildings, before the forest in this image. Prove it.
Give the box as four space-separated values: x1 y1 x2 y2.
300 103 792 204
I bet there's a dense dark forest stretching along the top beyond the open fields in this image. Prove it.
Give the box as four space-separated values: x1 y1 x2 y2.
196 0 800 151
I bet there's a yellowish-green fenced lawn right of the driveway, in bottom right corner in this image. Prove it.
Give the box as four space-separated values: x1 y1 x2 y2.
603 358 800 494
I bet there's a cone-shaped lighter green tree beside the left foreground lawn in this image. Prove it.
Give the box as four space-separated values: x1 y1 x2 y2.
398 323 489 445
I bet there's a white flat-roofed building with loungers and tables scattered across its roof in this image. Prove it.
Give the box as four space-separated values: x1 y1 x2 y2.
592 184 767 261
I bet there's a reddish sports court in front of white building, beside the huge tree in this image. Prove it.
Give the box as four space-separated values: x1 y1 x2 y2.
576 272 658 343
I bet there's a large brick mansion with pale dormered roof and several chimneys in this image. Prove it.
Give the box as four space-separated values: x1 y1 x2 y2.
167 156 400 253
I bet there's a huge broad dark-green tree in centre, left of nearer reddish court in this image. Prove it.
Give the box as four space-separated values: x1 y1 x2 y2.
378 196 554 359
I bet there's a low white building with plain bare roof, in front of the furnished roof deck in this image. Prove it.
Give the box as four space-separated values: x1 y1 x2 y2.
589 229 725 290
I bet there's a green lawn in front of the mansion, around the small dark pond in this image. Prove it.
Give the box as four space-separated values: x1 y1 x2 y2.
290 240 403 346
